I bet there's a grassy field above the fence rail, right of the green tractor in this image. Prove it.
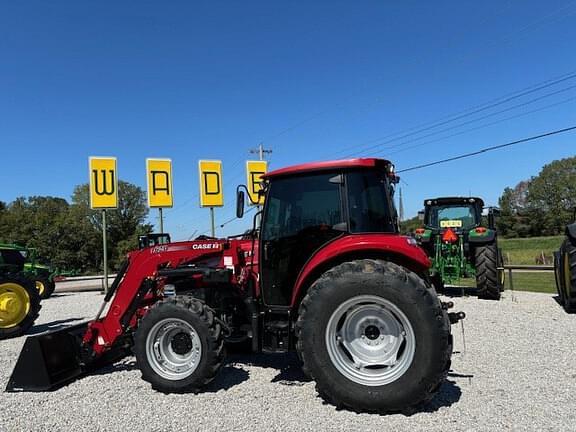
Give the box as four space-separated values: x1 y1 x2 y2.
498 236 564 265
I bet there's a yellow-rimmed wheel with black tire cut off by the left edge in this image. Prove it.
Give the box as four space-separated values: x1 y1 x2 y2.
0 275 41 339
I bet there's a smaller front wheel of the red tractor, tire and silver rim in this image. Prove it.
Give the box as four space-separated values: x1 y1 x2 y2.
134 295 224 393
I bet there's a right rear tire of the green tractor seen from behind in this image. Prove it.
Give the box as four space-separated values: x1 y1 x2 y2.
475 242 502 300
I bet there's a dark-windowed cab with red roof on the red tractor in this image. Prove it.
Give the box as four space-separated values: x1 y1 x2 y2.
238 159 398 306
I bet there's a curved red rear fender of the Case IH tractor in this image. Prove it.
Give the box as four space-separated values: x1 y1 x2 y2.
290 234 431 307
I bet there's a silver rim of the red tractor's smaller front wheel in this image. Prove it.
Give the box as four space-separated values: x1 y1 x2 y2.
146 318 202 381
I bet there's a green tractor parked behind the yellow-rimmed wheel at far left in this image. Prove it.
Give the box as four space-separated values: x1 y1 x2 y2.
0 244 60 299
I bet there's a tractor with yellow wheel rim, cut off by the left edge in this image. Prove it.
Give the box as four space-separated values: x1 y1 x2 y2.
0 248 41 339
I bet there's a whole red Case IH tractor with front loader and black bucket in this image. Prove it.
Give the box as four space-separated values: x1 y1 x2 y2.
7 159 464 412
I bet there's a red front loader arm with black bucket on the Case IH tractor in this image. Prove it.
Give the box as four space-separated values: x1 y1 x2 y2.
6 240 247 392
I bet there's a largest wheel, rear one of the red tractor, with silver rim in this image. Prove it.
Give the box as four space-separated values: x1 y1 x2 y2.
296 259 452 413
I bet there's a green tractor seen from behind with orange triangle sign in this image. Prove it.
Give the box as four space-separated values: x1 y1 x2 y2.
415 197 504 300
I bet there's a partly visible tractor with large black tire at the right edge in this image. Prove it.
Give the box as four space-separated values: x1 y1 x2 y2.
554 209 576 313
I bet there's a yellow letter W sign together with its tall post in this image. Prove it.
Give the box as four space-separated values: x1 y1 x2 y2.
88 157 118 293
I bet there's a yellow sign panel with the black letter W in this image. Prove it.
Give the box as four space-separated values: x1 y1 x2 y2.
88 157 118 209
